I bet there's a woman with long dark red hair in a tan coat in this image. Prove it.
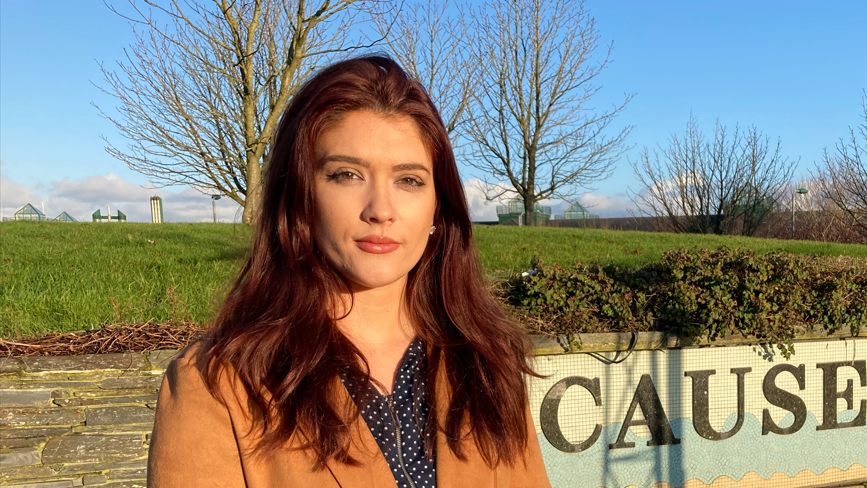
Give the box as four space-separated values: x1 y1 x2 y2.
142 57 549 488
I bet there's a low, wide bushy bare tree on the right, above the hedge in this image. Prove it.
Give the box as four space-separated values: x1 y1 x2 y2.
631 115 797 236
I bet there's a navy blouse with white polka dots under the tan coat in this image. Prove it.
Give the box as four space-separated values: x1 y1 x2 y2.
341 338 436 488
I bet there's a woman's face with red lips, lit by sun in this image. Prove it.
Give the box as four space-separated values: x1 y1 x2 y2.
313 111 436 289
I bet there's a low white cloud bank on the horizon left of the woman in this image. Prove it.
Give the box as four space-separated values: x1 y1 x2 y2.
0 173 240 222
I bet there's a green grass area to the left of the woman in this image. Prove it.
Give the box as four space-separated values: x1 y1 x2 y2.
0 222 251 338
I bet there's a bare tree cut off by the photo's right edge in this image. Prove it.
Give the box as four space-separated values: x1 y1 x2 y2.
814 91 867 238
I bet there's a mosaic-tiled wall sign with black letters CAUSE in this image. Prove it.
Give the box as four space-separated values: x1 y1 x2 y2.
530 338 867 488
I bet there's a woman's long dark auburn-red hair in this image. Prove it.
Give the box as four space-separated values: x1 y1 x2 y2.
203 56 532 467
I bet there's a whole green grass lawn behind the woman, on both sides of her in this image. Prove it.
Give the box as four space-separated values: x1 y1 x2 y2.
0 222 867 338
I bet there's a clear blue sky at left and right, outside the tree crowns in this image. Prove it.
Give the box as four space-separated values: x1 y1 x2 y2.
0 0 867 220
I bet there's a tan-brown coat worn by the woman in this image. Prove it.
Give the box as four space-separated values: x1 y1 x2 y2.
142 345 551 488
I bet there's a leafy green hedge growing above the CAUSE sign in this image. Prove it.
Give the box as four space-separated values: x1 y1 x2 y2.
503 248 867 357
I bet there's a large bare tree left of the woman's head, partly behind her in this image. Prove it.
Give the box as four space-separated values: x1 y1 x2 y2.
97 0 372 224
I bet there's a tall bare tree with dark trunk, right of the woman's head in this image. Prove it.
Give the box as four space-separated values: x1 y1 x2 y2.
465 0 632 225
